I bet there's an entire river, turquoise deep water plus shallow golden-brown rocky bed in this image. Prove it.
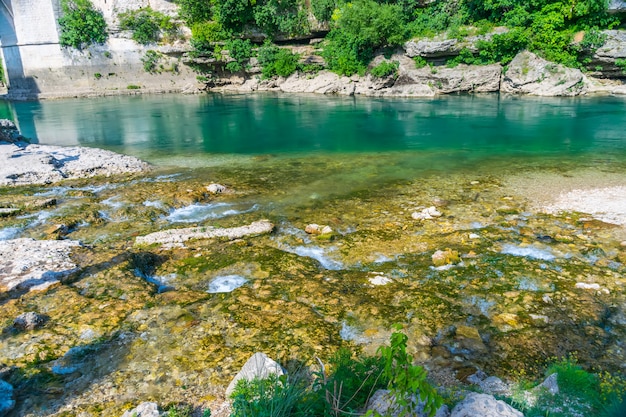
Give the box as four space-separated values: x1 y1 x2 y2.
0 95 626 415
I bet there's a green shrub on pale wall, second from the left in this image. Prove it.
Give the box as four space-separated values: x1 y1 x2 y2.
119 7 178 45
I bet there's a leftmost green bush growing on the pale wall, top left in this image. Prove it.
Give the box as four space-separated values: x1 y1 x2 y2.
59 0 107 49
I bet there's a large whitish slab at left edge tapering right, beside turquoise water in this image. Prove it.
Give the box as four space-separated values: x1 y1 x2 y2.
0 142 149 186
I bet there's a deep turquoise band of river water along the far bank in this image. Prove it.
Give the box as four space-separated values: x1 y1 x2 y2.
0 94 626 162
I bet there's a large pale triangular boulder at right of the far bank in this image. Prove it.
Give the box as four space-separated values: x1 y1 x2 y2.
500 51 587 96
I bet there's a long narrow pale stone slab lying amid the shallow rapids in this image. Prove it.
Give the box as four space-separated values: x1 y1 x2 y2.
135 220 274 246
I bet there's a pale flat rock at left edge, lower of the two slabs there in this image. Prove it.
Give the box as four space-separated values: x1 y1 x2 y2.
0 238 80 292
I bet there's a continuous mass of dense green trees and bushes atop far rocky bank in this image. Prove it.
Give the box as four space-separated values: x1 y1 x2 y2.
177 0 620 75
